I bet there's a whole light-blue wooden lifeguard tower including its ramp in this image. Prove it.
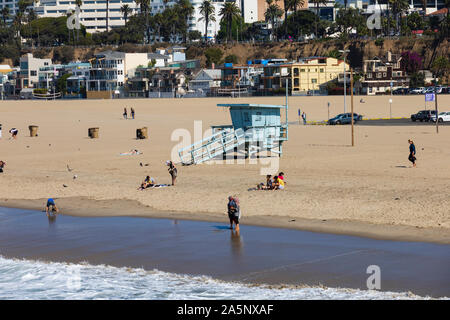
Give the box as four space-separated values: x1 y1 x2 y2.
178 103 288 165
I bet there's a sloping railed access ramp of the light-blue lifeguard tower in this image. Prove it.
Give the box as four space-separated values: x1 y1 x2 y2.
178 126 245 165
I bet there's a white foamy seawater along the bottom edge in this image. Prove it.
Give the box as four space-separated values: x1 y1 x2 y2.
0 256 442 300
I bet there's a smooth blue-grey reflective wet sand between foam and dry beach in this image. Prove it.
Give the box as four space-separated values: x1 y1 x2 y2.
0 208 450 297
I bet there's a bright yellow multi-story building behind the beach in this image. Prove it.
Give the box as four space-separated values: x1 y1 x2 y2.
290 57 350 95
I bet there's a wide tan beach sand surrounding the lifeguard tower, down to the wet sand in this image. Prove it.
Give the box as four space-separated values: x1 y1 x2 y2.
0 95 450 243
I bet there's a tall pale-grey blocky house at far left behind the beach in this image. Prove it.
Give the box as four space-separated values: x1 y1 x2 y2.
16 53 52 90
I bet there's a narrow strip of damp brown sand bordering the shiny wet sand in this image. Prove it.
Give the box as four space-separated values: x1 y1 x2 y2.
0 197 450 244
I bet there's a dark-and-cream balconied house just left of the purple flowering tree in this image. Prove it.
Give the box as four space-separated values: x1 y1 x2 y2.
361 51 409 95
